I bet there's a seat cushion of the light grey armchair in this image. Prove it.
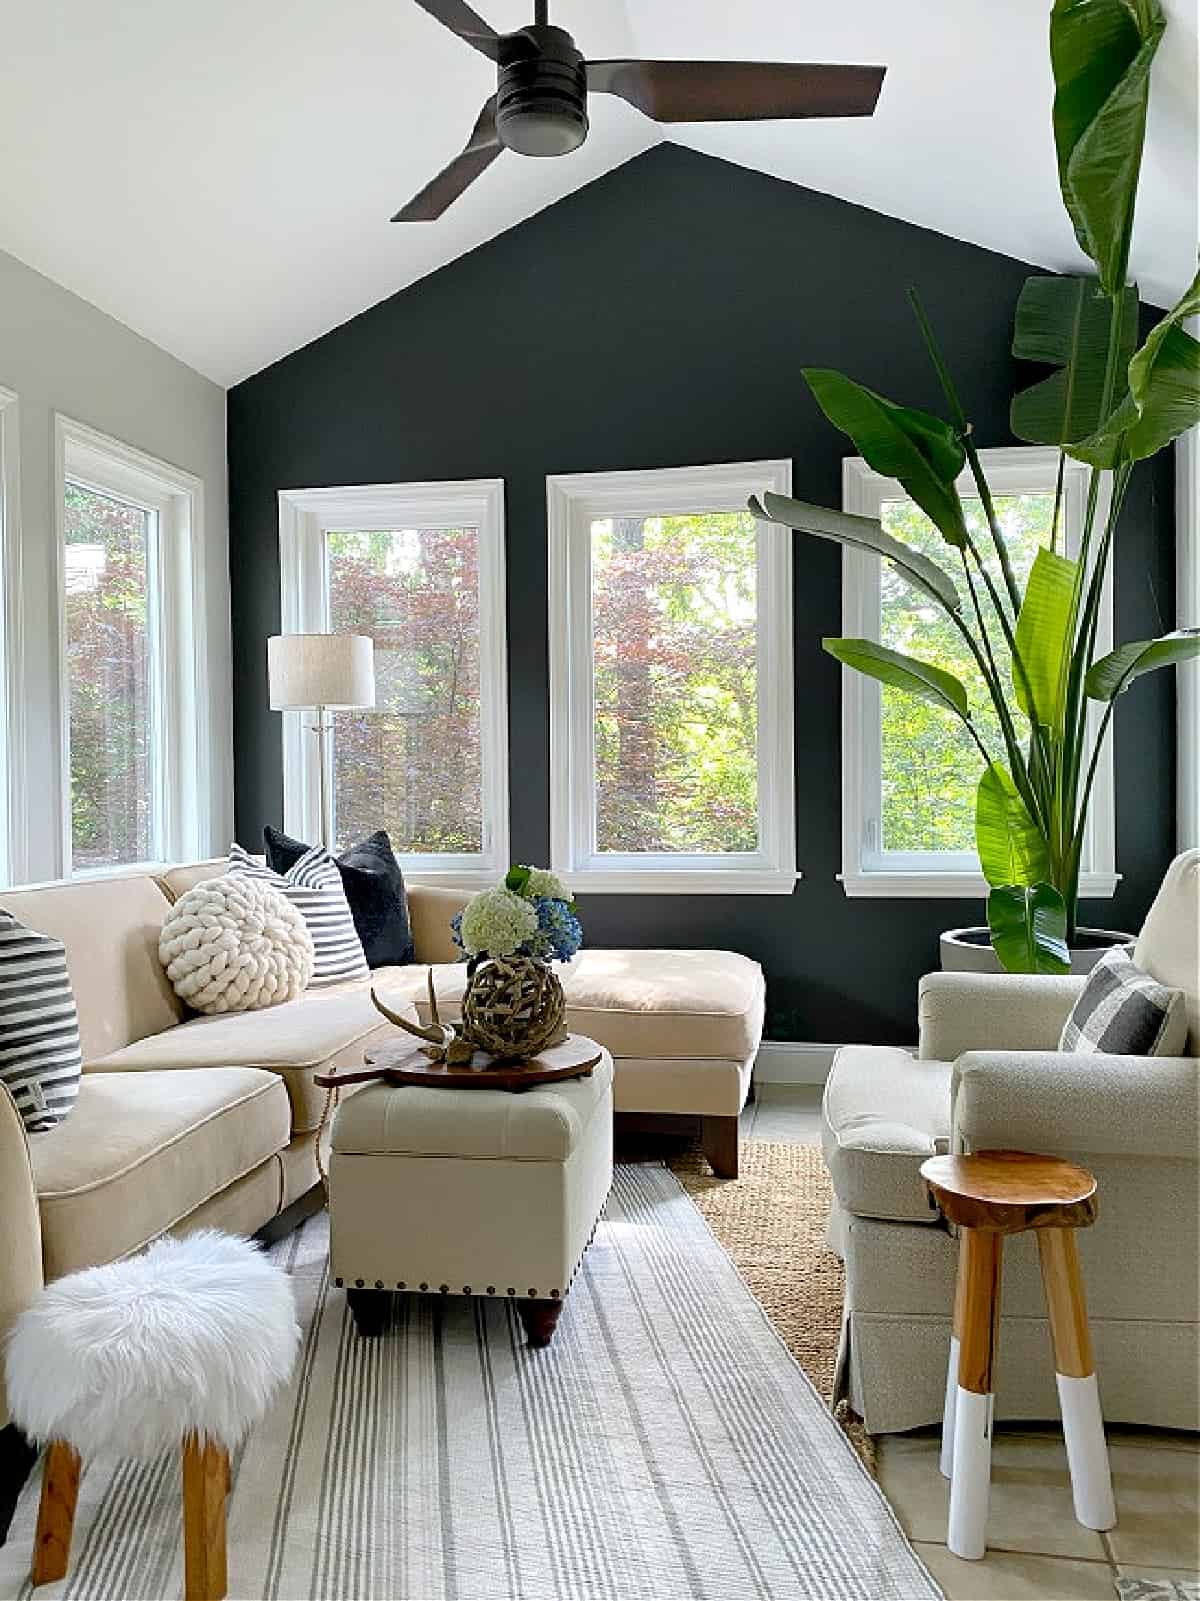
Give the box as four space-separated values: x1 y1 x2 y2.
821 1045 950 1223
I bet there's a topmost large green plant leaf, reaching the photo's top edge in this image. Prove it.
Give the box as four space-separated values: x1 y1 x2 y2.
1050 0 1166 295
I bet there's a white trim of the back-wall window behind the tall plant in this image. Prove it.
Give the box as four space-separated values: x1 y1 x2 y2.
840 445 1120 900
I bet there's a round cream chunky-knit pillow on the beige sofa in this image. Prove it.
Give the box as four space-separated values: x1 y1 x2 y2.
158 876 314 1012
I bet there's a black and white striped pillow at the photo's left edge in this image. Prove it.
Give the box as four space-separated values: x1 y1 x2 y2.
0 909 83 1134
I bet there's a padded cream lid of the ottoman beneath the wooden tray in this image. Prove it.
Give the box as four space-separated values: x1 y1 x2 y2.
333 1057 613 1162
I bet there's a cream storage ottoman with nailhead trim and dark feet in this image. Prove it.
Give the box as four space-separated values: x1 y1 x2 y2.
330 1050 613 1345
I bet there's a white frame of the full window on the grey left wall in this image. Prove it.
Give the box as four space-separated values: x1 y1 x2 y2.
54 413 211 879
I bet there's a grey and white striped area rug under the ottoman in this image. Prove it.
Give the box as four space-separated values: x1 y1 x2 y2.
0 1164 939 1601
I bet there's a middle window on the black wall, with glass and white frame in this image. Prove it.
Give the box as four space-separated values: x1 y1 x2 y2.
547 461 797 893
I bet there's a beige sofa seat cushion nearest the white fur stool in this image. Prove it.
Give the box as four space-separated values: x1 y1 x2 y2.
29 1068 290 1279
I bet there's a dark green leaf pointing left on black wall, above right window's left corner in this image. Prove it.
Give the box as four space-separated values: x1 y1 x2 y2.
802 367 966 546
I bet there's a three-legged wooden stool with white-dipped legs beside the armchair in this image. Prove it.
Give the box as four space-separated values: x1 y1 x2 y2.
922 1151 1117 1561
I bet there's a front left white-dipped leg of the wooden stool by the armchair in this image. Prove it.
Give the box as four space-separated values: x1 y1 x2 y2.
946 1228 1003 1561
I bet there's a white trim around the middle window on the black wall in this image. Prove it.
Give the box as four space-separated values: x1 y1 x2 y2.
546 461 800 895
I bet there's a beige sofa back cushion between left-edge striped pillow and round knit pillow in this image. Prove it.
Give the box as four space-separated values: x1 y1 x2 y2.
3 877 184 1061
